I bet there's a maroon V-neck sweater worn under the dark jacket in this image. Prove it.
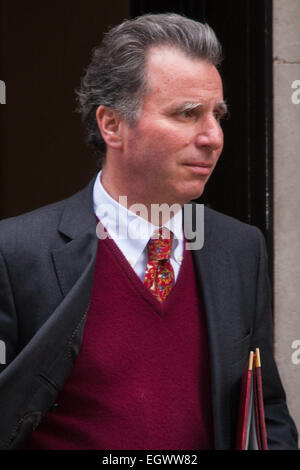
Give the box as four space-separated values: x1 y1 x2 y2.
24 238 213 450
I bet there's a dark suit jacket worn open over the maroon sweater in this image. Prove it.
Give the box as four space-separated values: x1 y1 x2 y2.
0 176 297 449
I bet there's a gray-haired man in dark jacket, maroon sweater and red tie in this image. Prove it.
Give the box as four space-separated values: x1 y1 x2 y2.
0 14 297 449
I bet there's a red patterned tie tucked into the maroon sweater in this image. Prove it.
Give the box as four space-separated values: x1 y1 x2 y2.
144 227 174 302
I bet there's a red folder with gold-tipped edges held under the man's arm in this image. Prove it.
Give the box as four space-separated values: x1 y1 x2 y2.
236 348 268 450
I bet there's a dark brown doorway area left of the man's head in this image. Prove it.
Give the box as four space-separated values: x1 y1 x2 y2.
0 0 130 218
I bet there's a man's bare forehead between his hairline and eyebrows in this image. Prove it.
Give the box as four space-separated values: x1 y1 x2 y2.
146 46 223 100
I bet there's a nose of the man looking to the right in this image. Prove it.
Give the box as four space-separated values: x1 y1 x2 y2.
195 115 223 150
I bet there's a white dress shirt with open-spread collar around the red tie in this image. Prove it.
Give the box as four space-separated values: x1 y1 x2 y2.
93 171 184 281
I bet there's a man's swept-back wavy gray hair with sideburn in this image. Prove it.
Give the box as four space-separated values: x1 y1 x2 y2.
76 13 222 167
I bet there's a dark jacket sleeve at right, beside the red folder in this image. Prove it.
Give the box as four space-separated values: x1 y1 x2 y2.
252 229 298 450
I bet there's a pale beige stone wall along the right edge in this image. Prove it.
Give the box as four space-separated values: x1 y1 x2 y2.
273 0 300 444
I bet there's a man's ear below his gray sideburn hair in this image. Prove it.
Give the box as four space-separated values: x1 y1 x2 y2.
96 105 122 149
